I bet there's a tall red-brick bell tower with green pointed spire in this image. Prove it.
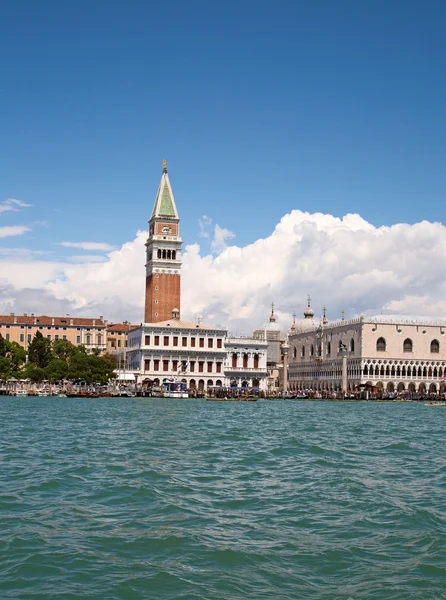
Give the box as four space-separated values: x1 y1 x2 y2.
144 160 182 323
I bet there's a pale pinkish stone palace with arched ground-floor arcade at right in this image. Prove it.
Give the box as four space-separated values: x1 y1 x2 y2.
289 311 446 394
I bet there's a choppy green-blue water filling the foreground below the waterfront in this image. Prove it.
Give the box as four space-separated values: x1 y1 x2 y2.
0 397 446 600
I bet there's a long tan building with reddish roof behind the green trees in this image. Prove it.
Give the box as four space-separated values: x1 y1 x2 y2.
0 313 107 353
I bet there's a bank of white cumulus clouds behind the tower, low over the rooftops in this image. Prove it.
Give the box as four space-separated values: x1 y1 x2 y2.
0 210 446 334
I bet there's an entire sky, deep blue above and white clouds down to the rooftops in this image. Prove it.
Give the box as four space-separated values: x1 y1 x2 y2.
0 0 446 334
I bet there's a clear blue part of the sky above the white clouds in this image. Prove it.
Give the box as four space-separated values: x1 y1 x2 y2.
0 0 446 257
